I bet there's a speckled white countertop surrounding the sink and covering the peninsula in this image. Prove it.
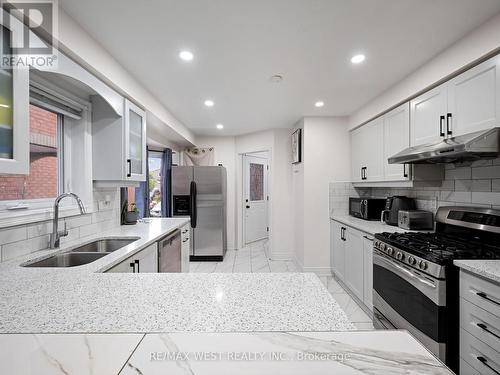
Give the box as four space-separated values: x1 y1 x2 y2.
0 219 354 333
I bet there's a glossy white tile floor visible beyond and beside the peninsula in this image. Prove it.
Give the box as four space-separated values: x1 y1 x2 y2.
189 241 374 330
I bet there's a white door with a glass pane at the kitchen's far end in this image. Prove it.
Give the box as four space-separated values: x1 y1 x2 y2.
243 155 268 244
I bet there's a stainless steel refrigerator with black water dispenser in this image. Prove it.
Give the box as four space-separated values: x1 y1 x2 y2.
172 166 227 261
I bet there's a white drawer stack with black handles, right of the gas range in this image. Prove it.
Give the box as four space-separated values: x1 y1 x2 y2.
460 271 500 375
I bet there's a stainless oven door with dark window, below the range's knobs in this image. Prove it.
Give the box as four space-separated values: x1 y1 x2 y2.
373 249 447 360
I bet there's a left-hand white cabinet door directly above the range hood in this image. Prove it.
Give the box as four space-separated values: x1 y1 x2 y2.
410 84 447 146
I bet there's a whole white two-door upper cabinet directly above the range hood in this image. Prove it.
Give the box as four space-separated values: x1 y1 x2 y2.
410 56 500 146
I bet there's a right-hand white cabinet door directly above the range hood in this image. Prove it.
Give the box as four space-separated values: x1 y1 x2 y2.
447 56 500 136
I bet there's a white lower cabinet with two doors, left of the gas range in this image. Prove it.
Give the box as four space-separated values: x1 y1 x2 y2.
330 220 373 312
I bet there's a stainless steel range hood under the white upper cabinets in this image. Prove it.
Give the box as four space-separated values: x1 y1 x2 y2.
389 128 500 164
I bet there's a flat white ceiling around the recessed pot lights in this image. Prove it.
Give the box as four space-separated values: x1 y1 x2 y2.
60 0 500 135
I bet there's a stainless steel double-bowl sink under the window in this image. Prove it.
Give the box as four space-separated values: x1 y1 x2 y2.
23 237 139 267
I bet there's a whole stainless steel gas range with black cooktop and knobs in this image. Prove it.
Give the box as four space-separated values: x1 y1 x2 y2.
373 207 500 370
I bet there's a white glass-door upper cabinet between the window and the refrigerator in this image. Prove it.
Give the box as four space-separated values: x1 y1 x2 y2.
92 95 146 185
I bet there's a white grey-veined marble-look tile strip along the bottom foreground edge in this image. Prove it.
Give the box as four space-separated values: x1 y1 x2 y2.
0 330 452 375
